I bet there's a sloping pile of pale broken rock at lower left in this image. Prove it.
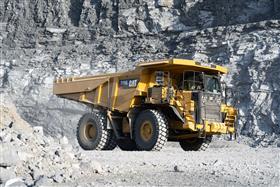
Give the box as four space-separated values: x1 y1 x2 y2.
0 105 103 186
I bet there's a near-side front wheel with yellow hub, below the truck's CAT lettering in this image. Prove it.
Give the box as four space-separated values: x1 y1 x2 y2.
133 110 168 151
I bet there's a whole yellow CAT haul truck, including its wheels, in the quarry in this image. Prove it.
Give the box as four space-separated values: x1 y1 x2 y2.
53 58 237 151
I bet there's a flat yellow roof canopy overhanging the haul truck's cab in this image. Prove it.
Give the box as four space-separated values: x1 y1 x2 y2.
137 58 228 74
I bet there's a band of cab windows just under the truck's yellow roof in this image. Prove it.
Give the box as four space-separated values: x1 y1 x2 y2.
180 71 221 93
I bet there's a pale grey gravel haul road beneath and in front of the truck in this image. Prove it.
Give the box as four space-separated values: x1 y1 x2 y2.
80 142 280 186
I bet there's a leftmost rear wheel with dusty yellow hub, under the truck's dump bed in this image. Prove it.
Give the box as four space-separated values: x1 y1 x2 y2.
77 112 108 150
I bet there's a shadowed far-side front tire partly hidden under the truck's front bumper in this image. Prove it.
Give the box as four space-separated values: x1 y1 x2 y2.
179 136 212 151
